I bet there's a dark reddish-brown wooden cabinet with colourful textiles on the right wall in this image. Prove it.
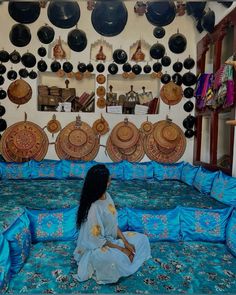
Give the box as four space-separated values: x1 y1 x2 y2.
194 8 236 175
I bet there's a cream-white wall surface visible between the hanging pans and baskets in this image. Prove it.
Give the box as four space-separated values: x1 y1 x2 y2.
0 1 232 162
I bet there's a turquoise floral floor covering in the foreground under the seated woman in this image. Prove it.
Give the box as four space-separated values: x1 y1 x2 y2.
8 241 236 294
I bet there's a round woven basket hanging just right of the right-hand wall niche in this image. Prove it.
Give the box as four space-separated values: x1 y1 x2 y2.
160 81 183 105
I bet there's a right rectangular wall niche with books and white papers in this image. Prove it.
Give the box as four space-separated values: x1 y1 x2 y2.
106 74 160 115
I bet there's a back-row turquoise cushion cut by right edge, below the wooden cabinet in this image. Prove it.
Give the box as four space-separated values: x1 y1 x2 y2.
211 171 236 206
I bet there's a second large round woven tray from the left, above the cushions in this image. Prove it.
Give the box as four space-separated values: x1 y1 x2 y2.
55 122 96 159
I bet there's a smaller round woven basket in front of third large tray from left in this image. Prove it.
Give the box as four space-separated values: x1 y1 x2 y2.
111 119 140 149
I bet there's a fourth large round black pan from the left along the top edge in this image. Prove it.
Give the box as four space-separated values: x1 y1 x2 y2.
146 1 176 27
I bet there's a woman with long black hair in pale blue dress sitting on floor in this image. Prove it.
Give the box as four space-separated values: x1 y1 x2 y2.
74 164 150 284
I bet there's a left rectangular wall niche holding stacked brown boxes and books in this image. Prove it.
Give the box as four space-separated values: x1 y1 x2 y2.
38 72 95 112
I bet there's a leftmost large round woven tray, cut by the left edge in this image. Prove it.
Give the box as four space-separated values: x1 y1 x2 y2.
1 121 49 162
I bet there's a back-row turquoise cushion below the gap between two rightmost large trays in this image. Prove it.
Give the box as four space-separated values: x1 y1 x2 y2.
123 161 153 180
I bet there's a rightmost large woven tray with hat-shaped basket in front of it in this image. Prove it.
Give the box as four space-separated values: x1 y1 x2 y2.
144 120 186 163
